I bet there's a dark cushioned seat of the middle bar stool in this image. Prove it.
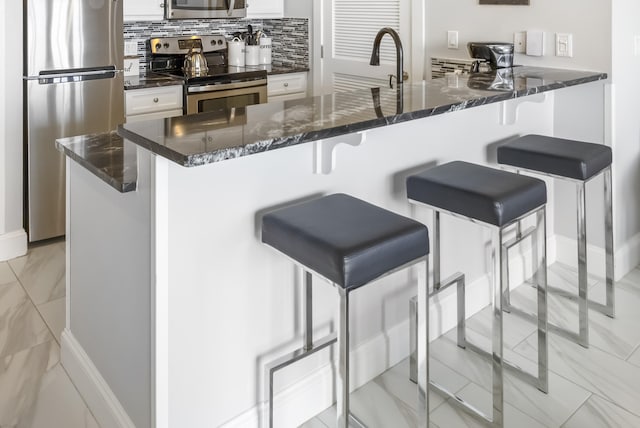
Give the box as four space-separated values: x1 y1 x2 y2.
407 161 547 226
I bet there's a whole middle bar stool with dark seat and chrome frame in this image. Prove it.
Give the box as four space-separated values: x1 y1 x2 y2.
407 161 548 426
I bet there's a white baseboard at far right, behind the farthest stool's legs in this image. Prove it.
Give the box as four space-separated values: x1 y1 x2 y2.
556 233 640 281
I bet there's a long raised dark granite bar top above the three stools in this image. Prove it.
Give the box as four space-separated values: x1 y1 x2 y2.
118 67 607 167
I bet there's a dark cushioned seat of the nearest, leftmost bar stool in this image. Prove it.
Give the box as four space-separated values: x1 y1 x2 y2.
262 194 429 290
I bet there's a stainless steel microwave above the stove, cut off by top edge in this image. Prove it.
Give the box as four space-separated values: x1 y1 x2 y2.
165 0 247 19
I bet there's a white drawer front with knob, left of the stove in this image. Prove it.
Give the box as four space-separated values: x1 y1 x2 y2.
125 85 182 116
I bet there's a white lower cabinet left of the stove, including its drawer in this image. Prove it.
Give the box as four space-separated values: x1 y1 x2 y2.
125 85 182 122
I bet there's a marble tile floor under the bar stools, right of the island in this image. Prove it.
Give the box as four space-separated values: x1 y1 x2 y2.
303 264 640 428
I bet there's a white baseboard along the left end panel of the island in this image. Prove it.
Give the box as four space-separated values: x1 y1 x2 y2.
60 329 135 428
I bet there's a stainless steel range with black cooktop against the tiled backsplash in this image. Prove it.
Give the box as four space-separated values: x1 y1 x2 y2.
149 36 267 114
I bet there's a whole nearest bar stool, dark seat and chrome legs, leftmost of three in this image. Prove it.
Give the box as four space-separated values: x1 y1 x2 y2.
262 194 429 428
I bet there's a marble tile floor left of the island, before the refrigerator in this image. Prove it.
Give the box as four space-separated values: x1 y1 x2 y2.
0 241 98 428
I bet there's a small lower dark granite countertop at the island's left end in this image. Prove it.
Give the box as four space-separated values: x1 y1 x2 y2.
56 131 138 193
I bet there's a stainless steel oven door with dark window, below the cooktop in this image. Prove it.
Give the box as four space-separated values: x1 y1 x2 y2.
185 83 267 114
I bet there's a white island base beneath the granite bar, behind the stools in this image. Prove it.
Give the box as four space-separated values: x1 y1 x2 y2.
62 82 606 428
